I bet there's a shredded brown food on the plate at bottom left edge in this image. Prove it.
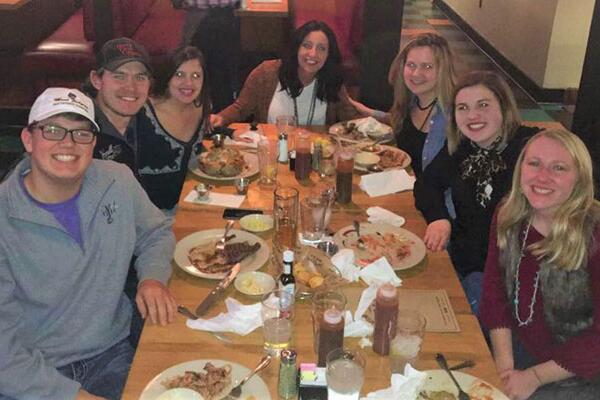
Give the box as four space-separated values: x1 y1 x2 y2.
161 362 231 400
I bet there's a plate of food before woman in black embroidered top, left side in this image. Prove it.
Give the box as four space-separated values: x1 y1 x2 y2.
188 147 258 181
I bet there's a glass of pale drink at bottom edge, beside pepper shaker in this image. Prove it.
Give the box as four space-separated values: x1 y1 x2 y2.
325 349 365 400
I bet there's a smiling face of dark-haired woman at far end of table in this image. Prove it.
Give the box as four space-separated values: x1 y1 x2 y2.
298 31 329 84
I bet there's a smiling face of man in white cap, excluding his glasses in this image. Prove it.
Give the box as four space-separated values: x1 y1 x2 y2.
21 115 96 195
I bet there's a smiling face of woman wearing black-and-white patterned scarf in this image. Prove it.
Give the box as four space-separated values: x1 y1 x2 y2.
454 85 504 148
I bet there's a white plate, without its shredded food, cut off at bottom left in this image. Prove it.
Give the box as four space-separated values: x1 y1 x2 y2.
140 360 271 400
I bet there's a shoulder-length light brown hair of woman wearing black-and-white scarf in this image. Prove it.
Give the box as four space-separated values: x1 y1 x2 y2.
447 71 521 154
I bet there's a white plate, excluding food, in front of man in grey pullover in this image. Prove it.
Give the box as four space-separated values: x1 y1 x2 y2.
173 229 269 279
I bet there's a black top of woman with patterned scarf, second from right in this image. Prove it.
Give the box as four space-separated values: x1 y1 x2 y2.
414 126 539 276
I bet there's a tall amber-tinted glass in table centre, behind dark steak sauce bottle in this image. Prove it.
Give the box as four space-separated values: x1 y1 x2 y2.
273 186 298 253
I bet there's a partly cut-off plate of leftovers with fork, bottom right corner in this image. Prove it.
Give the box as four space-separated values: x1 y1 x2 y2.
417 369 509 400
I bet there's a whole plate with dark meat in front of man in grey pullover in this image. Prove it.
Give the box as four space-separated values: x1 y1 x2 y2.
173 229 269 279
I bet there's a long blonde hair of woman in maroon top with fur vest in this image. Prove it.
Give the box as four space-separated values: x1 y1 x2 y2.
497 129 600 271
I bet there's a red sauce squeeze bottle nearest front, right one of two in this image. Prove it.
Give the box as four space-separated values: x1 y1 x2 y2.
373 283 398 356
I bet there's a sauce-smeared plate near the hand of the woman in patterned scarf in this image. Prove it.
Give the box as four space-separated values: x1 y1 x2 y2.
333 223 427 271
